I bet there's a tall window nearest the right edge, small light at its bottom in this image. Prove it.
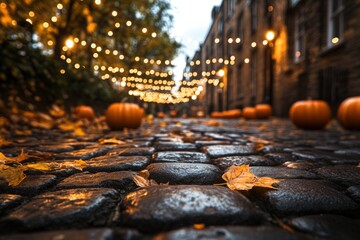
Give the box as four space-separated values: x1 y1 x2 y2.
327 0 344 47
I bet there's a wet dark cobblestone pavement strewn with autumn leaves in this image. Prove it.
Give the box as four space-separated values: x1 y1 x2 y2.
0 119 360 240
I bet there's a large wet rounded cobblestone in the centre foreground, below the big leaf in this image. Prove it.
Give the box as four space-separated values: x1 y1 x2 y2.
120 185 262 232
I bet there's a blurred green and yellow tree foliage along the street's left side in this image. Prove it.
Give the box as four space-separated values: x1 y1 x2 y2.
0 0 180 109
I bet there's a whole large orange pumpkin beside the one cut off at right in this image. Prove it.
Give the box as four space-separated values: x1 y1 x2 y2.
289 100 331 129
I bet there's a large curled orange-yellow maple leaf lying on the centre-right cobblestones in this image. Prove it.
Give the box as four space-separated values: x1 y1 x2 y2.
222 165 279 190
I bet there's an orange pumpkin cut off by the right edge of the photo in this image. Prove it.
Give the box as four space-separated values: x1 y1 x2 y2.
337 96 360 130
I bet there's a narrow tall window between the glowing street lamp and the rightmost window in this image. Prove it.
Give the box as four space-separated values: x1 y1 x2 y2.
294 7 305 62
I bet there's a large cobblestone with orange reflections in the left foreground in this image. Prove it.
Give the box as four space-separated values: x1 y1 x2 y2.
0 188 119 232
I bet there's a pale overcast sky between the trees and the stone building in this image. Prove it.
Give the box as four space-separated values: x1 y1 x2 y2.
170 0 222 80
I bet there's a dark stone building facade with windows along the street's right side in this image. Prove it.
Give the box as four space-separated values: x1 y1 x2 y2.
190 0 360 116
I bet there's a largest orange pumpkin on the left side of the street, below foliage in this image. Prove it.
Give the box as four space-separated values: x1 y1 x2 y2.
105 103 144 130
